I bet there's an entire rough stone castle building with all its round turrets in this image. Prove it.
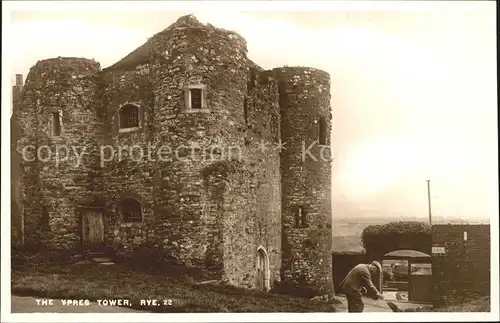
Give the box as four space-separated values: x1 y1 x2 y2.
11 16 332 293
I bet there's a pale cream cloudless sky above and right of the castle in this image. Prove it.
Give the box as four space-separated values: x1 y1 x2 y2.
3 1 498 222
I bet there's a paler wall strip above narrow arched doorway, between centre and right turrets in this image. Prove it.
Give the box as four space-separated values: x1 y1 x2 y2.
217 65 281 288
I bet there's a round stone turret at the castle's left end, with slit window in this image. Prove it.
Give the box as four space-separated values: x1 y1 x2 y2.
18 57 102 248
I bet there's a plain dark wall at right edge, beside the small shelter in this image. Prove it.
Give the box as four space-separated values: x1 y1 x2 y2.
432 224 491 307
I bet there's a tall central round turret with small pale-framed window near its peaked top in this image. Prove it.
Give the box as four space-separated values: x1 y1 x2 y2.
144 16 252 268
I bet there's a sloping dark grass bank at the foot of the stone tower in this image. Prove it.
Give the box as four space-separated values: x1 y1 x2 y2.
12 256 335 313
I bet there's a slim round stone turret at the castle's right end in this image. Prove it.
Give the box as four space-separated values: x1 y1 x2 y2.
274 67 333 295
